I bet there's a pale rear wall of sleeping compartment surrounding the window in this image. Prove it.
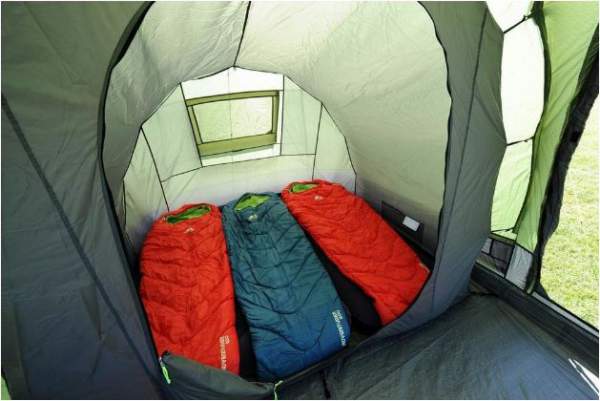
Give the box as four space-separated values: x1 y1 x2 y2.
124 68 356 251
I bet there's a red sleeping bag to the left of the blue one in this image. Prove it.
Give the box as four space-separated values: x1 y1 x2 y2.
140 204 240 374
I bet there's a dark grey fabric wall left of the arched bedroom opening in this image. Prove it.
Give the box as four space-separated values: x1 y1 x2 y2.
2 3 159 398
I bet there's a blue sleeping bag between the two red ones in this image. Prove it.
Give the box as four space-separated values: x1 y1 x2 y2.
223 193 350 381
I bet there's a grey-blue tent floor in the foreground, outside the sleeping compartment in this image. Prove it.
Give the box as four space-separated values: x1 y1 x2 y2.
280 295 598 399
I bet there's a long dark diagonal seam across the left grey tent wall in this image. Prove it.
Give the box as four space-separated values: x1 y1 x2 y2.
2 93 156 380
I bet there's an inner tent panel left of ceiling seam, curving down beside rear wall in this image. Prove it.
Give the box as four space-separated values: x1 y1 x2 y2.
103 2 247 223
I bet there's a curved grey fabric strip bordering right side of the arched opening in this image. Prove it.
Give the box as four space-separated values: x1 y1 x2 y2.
379 2 505 336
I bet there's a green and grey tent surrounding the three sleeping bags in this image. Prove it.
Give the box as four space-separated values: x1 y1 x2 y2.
2 2 598 398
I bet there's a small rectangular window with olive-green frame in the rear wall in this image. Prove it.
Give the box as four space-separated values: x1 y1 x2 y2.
185 91 279 156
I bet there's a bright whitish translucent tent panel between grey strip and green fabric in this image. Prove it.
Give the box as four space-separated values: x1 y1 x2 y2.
491 12 544 238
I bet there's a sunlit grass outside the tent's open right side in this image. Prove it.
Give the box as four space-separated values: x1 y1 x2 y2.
541 102 598 327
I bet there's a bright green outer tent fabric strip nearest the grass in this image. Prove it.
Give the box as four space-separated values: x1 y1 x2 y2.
514 1 598 252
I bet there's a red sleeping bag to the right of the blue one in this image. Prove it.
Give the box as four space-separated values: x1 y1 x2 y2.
281 180 429 324
